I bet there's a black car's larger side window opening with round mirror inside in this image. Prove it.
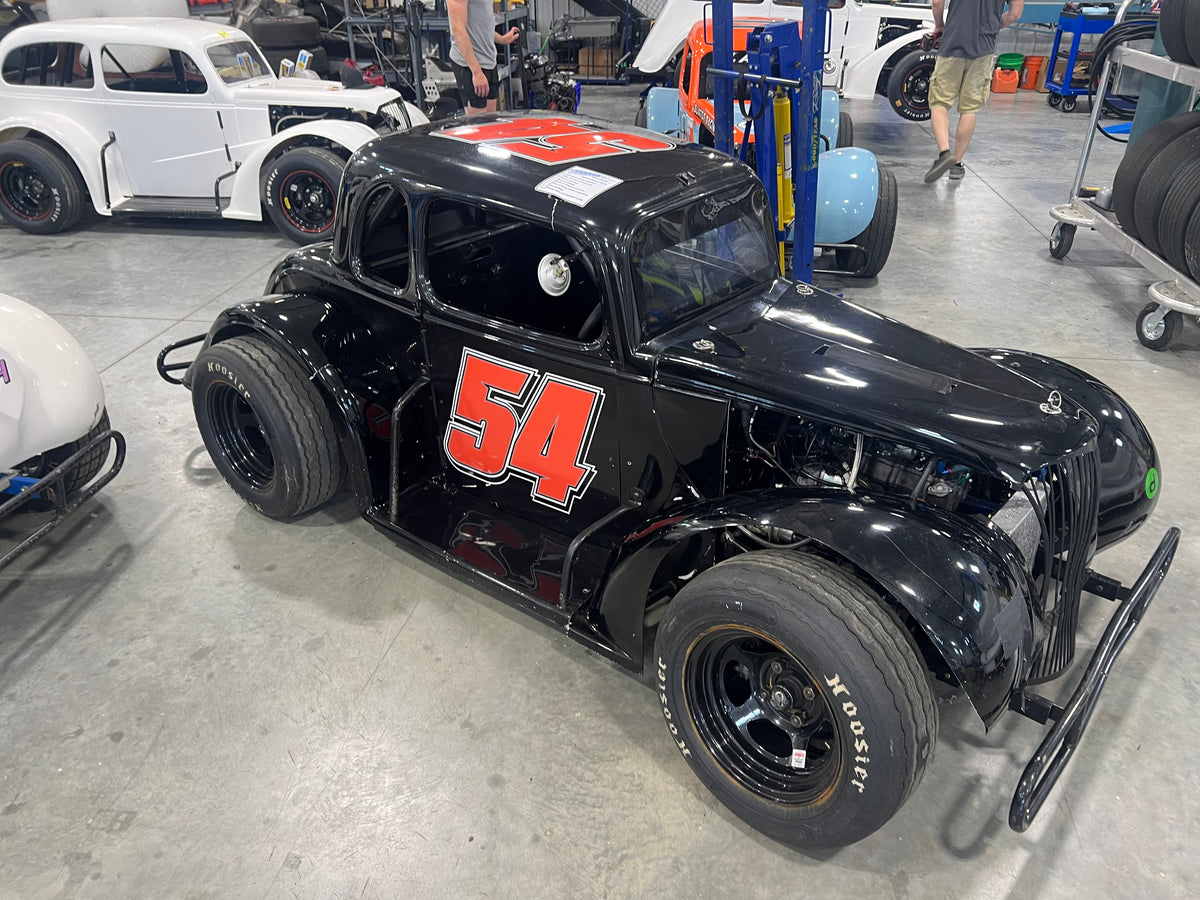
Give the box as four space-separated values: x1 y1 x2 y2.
425 199 604 342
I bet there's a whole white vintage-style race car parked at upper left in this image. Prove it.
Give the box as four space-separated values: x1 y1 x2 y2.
0 18 428 244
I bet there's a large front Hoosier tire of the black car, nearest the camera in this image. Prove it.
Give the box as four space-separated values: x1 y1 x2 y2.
655 551 937 847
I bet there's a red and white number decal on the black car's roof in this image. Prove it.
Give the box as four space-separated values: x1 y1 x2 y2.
433 116 676 166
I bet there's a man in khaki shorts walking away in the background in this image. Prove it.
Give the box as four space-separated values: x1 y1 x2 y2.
925 0 1025 184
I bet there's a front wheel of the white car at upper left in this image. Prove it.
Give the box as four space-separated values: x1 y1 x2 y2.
263 146 346 244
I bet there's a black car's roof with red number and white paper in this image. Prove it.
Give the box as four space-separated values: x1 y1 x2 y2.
343 110 751 247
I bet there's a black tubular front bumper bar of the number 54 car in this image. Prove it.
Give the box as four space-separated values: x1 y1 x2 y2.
1008 528 1180 832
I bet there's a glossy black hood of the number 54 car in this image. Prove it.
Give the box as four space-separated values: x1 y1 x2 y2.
652 280 1096 482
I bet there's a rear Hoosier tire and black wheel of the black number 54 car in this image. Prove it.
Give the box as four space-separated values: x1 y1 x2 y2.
192 335 342 518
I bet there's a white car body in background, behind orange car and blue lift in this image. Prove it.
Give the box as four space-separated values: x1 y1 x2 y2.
634 0 934 100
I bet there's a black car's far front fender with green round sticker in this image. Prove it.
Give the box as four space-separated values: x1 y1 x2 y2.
976 349 1163 550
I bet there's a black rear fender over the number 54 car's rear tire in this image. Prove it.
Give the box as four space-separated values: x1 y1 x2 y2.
184 294 372 512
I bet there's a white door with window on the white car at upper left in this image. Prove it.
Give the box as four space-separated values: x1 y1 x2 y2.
100 43 233 198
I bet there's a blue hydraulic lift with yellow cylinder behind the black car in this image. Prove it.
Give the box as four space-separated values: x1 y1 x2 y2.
710 0 828 284
